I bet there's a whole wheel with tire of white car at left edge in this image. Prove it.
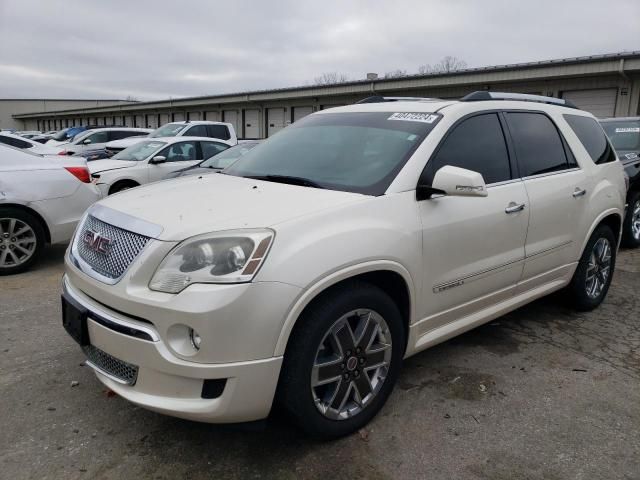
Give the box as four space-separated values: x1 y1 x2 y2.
0 207 46 275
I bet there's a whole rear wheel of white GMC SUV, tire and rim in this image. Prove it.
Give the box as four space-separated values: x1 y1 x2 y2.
567 225 617 311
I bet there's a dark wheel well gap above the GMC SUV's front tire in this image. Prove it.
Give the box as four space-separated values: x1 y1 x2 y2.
289 270 411 347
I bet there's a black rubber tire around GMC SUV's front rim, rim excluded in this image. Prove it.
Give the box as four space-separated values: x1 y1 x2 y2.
278 282 405 439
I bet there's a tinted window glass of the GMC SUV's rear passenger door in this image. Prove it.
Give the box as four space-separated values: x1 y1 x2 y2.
507 112 569 177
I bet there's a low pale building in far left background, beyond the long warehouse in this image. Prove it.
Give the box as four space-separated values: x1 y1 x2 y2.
0 98 131 130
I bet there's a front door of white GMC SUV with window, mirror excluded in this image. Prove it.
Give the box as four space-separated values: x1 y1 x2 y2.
419 113 529 333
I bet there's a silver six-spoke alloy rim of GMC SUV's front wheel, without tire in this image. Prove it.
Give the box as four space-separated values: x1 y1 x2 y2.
311 309 392 420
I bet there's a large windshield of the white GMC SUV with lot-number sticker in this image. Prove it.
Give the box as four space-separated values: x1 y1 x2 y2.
224 112 441 195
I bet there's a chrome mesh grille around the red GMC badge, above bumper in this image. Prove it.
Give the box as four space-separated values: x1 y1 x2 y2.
75 215 149 280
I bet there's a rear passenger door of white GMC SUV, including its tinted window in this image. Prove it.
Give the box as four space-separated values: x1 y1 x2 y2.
505 111 591 288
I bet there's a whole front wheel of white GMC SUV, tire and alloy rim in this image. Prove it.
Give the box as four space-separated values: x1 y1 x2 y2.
278 281 405 438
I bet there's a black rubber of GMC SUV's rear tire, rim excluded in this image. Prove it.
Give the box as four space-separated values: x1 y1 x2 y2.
570 225 618 311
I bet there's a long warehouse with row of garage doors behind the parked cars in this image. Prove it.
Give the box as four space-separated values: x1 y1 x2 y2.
6 51 640 138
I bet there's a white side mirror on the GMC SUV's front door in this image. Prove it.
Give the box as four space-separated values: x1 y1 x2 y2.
417 165 489 200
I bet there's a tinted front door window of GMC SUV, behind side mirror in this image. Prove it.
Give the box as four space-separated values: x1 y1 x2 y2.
423 113 511 184
